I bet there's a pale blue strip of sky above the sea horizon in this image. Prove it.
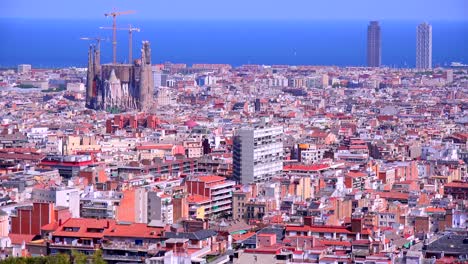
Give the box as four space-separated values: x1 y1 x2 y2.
0 0 468 21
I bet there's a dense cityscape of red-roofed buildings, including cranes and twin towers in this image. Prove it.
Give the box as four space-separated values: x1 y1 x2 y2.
0 2 468 264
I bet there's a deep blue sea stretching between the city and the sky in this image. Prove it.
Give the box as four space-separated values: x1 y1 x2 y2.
0 18 468 67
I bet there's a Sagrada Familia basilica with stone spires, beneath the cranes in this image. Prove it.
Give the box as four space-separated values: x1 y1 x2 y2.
86 41 154 112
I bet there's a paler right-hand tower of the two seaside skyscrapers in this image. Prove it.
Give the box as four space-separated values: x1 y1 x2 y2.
416 22 432 70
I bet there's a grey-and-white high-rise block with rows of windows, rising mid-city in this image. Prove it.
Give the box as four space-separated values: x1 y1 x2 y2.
233 121 283 184
